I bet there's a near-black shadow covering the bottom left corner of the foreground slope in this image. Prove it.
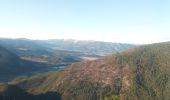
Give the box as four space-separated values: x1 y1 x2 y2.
0 86 61 100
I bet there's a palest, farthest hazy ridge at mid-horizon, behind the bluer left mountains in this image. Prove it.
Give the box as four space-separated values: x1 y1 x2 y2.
42 39 135 56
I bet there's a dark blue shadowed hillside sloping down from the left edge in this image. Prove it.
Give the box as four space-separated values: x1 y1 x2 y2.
0 46 50 81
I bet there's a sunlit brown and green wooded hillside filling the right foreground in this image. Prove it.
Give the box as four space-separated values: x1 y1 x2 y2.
2 42 170 100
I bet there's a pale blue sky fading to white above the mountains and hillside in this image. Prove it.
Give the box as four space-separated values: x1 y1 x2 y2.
0 0 170 44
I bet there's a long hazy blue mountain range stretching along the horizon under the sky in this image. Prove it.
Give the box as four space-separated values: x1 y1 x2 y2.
0 38 135 56
